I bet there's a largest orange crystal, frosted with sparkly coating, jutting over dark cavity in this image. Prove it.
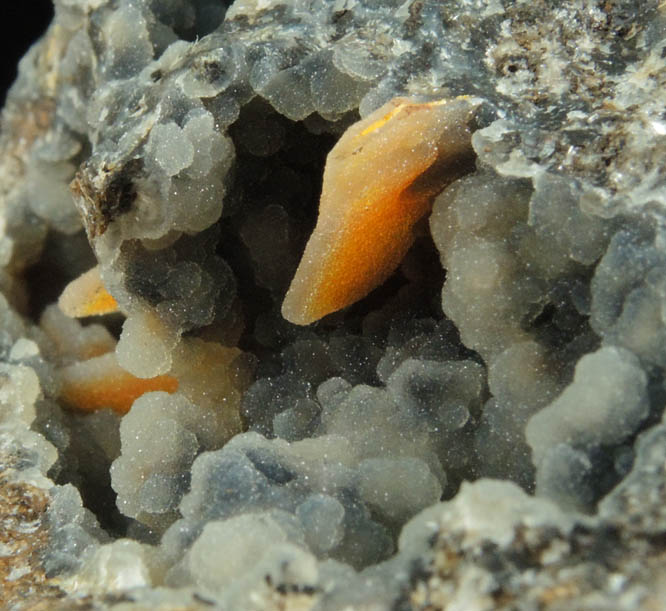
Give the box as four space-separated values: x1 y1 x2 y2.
282 96 479 325
